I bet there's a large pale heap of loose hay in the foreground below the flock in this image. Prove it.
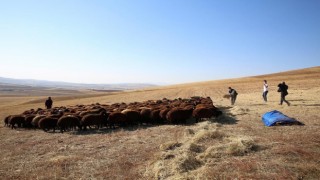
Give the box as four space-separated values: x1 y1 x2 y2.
147 122 258 179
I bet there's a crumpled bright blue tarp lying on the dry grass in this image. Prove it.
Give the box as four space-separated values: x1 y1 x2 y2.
262 110 301 126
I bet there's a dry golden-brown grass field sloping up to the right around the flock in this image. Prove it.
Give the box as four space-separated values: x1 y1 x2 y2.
0 67 320 179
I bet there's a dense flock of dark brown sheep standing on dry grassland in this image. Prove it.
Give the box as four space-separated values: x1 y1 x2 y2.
4 96 222 132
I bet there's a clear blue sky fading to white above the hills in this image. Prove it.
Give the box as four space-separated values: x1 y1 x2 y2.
0 0 320 84
